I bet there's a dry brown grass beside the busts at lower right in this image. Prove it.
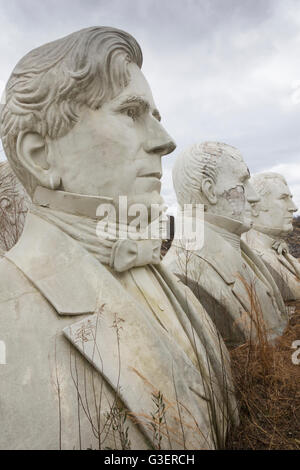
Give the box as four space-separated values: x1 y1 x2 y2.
227 302 300 450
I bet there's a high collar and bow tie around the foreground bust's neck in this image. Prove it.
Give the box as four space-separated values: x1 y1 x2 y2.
31 187 161 272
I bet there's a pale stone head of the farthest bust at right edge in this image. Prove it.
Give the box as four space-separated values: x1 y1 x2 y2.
251 172 298 235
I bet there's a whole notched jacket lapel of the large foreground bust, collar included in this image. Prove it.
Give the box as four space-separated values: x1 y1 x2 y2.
6 214 218 448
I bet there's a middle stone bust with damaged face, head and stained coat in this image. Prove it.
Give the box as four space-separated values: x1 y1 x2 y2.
164 142 286 345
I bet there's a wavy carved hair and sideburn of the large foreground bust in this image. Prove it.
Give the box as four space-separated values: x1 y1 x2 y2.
0 27 143 194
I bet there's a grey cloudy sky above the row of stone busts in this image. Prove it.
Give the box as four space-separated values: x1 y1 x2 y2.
0 0 300 215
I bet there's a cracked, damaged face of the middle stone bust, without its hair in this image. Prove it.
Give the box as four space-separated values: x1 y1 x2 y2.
211 151 259 222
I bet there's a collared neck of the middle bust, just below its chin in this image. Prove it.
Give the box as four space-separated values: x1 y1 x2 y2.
204 213 250 251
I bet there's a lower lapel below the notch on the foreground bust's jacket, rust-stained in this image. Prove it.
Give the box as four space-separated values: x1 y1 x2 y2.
64 288 214 449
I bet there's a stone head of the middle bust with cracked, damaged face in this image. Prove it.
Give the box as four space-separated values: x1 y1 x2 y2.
173 142 259 222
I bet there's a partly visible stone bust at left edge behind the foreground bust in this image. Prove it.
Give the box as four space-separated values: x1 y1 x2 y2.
0 162 29 253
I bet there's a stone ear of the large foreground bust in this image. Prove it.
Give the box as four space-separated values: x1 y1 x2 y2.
16 131 60 189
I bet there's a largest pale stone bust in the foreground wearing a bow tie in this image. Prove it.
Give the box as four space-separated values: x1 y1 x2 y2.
0 27 237 449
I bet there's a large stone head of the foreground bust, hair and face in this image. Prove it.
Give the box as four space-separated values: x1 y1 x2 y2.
1 27 175 208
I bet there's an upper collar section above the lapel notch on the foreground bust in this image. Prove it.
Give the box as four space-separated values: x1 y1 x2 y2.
6 213 100 315
